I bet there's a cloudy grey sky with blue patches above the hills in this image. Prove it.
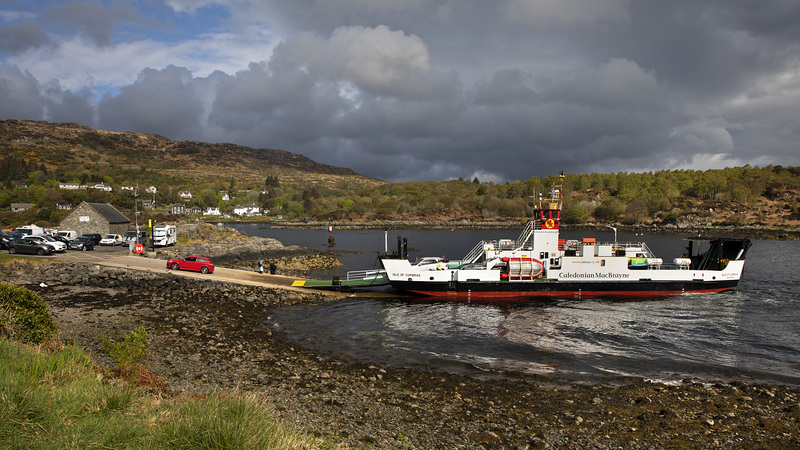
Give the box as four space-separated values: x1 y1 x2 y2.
0 0 800 182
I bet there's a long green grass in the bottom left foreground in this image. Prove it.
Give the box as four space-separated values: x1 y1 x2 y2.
0 339 320 449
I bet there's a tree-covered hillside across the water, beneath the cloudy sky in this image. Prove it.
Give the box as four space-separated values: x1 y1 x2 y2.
0 120 800 228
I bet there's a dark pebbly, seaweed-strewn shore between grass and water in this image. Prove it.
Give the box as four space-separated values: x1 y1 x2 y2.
0 263 800 449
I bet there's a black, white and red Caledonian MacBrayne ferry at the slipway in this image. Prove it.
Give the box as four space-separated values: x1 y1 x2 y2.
381 172 751 300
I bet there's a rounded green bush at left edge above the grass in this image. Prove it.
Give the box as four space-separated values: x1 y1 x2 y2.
0 283 58 344
